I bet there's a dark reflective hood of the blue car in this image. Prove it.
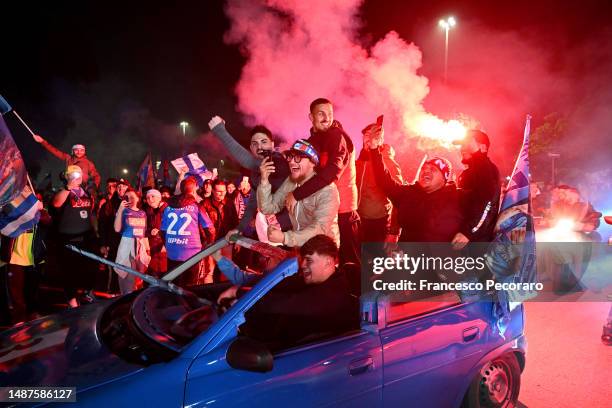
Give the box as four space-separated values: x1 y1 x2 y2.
0 300 142 391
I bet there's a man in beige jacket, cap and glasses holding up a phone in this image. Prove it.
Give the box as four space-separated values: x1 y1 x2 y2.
257 139 340 247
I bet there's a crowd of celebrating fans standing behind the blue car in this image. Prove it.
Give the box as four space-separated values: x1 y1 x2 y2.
1 98 604 324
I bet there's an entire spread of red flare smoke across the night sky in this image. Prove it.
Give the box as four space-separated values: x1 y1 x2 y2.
226 0 610 179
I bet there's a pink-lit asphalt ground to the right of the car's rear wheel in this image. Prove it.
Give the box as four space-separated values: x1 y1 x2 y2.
519 302 612 408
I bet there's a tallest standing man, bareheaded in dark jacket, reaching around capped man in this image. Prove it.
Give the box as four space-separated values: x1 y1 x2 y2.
287 98 361 265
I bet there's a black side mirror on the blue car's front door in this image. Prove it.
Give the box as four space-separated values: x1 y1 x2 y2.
226 337 274 373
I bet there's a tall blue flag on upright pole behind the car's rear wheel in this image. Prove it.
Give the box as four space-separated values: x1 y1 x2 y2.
486 115 537 335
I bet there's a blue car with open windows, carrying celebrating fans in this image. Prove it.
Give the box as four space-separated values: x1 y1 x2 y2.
0 259 526 408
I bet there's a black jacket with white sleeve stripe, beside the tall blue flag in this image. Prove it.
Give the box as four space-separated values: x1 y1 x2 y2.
458 152 501 242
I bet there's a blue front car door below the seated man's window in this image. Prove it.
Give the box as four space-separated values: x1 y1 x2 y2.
185 330 382 408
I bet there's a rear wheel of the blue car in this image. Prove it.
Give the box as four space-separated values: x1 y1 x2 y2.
461 353 521 408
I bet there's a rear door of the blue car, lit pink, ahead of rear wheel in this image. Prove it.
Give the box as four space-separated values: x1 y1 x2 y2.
380 293 491 407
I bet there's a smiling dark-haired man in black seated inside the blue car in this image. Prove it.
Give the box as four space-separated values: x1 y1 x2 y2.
219 235 359 350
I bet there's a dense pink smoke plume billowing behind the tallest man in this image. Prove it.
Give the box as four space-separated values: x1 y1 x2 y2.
226 0 442 161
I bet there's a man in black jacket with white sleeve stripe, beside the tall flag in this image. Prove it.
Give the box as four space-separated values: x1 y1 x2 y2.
452 129 501 249
